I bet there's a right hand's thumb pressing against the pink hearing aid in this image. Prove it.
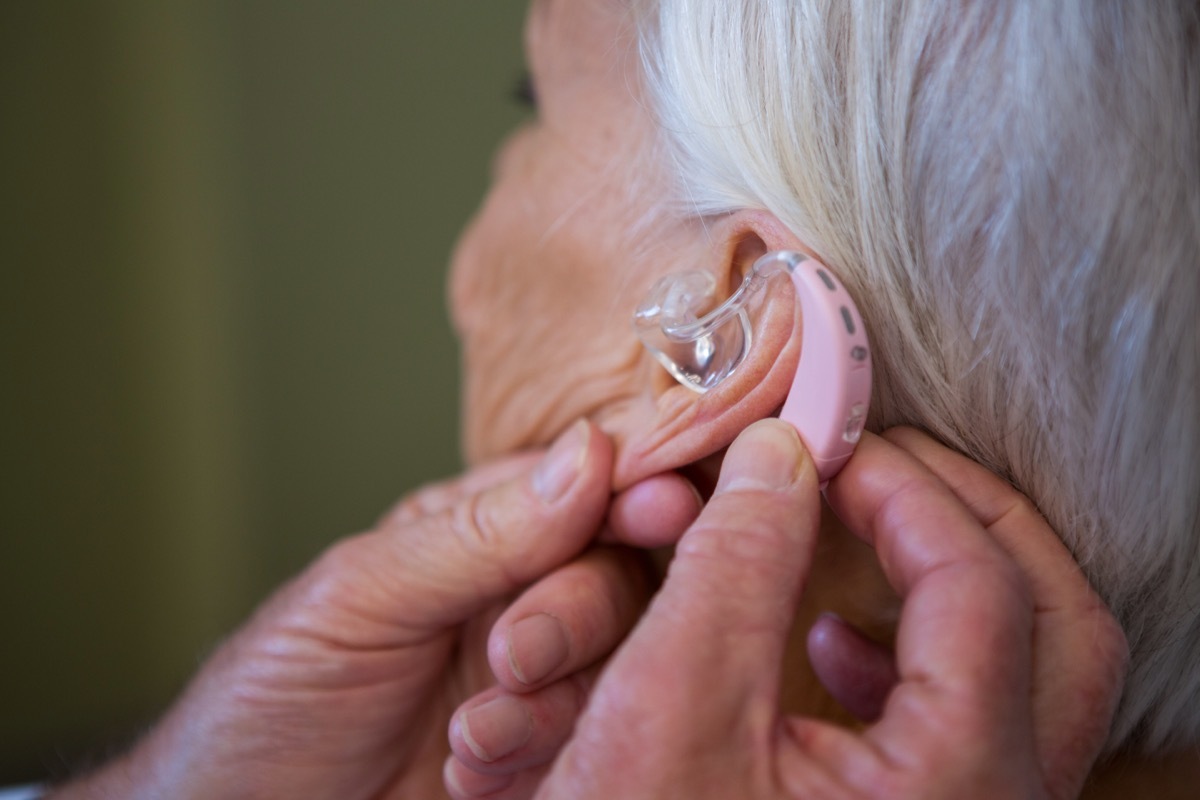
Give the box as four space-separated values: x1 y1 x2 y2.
539 420 820 798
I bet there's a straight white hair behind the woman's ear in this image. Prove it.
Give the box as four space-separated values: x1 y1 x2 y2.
638 0 1200 750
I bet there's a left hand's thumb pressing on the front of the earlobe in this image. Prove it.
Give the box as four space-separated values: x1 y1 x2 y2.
306 421 612 646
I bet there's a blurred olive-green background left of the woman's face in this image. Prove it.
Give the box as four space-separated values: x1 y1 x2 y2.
0 0 524 784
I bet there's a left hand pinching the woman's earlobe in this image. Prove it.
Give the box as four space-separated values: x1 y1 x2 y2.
55 422 700 800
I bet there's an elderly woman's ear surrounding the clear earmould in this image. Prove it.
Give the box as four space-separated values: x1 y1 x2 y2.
613 211 808 489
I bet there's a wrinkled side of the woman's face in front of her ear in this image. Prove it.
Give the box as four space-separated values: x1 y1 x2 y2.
450 0 706 463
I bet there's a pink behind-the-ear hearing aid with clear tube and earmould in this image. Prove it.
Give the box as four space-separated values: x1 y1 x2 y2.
634 251 871 486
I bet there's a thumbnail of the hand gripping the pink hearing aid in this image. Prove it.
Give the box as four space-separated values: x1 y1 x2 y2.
716 419 804 493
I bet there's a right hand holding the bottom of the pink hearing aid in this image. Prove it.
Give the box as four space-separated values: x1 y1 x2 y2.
446 421 1126 799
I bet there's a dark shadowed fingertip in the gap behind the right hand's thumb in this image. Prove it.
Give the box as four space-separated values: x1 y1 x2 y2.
808 614 900 722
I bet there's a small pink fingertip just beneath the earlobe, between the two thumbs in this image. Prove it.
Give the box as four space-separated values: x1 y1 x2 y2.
601 473 704 549
